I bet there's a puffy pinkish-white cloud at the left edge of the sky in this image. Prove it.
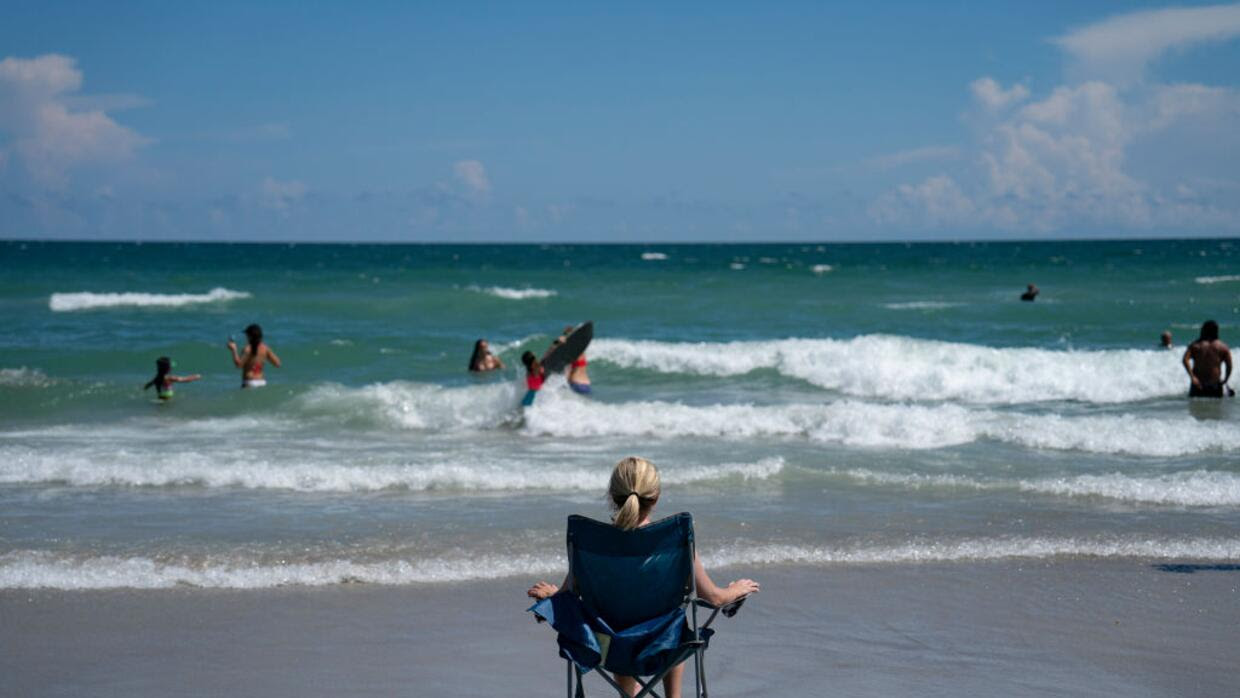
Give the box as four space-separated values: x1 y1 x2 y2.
0 53 150 188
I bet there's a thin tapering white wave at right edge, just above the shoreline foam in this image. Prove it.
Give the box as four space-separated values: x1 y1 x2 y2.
838 469 1240 507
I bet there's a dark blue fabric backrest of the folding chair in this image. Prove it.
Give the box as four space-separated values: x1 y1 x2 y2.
568 513 693 631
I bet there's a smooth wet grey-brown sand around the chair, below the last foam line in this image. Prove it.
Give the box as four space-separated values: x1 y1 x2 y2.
0 560 1240 698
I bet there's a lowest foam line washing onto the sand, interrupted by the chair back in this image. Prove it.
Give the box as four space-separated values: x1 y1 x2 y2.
0 537 1240 589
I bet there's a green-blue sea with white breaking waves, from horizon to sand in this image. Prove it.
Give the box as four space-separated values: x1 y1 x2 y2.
0 241 1240 589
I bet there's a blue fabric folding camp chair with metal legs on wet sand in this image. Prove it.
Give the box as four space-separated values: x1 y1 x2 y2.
529 513 745 698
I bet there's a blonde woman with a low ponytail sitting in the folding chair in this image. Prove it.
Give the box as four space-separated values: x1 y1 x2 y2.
526 457 758 698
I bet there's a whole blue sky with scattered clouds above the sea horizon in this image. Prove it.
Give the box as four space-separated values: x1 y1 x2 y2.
0 0 1240 242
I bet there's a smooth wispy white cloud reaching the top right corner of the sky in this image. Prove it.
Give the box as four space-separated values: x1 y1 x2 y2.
1053 4 1240 83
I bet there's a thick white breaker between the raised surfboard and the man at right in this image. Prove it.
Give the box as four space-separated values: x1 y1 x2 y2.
590 335 1187 404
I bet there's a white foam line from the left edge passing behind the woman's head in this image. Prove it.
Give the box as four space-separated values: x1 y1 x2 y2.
0 445 784 492
